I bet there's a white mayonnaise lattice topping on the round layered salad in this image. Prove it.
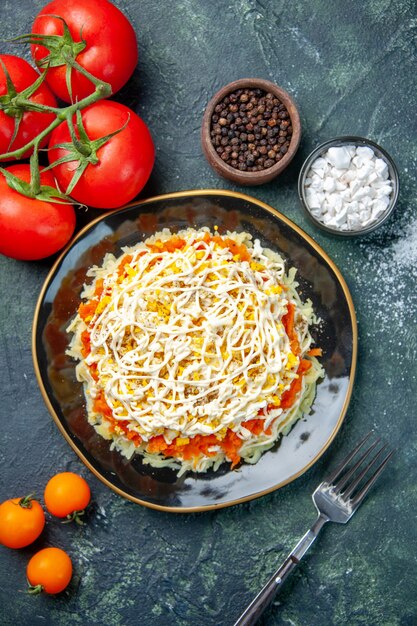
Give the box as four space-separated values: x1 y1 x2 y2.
68 229 322 470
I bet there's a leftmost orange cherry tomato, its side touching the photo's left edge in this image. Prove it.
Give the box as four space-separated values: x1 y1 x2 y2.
0 495 45 548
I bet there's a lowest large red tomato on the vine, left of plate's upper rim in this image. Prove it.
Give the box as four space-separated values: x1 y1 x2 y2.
0 163 75 261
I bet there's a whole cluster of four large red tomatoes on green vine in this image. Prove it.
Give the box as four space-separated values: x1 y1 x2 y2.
0 0 155 260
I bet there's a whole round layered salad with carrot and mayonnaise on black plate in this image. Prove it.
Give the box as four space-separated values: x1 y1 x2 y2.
67 228 322 473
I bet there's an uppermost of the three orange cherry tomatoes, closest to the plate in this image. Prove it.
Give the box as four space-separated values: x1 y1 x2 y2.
44 472 91 523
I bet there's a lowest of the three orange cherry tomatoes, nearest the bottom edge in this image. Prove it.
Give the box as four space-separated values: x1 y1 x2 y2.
26 548 72 594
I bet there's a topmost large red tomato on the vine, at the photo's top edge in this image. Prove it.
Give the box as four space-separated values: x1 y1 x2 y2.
31 0 138 102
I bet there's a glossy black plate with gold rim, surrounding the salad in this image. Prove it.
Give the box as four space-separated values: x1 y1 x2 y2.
32 190 357 512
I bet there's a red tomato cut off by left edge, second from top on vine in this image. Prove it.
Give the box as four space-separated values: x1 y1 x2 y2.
0 54 57 160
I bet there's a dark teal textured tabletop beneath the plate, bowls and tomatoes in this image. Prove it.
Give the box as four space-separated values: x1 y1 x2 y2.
0 0 417 626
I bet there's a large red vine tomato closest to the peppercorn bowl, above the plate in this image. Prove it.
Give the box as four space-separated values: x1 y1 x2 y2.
48 100 155 209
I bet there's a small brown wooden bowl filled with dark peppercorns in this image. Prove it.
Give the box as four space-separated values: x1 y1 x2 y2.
201 78 301 185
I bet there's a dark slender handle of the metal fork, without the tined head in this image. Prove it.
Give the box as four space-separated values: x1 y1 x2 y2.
234 515 329 626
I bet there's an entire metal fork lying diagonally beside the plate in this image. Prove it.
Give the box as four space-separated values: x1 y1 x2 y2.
234 431 394 626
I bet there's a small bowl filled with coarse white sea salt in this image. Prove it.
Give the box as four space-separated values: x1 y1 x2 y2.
298 136 399 236
